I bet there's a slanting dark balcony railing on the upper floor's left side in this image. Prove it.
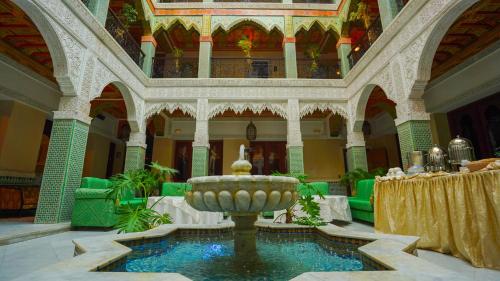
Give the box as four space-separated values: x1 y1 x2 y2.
106 9 144 68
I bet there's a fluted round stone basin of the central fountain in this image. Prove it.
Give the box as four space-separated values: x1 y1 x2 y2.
185 175 299 212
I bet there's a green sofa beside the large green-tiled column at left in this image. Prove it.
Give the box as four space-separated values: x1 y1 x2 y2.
71 177 145 227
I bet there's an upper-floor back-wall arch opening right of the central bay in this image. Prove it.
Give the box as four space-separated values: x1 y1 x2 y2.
295 22 341 79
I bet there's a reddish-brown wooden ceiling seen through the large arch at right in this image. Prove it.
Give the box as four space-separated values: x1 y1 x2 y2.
431 0 500 80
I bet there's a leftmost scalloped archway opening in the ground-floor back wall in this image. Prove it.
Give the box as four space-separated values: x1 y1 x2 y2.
146 109 196 182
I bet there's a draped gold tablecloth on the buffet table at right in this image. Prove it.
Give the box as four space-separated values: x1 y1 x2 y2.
374 170 500 269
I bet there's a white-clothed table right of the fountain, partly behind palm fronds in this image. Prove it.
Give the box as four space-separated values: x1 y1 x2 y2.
274 195 352 223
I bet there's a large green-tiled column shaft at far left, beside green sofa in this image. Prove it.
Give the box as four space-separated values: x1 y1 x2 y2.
35 119 89 223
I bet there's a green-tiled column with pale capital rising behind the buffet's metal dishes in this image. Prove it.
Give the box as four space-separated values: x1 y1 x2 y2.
395 99 432 170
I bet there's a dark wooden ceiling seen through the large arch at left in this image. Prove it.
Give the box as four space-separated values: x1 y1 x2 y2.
0 1 55 81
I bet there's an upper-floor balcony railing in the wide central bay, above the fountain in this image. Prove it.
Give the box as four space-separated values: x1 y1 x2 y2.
211 58 285 78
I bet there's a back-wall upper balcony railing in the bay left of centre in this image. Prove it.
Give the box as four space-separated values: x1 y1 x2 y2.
151 56 198 78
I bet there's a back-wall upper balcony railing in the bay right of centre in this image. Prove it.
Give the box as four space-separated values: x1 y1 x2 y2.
297 59 342 79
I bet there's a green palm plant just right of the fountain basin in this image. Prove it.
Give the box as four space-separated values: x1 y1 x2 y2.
273 172 326 226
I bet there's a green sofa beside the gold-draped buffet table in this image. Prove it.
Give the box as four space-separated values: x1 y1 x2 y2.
348 179 375 223
